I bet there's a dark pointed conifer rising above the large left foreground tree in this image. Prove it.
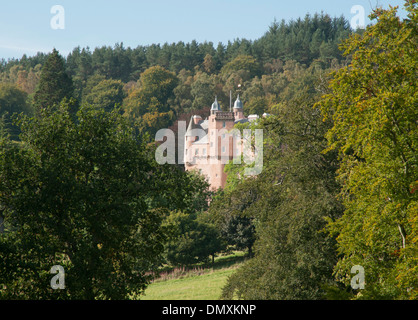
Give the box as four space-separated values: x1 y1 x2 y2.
33 49 77 113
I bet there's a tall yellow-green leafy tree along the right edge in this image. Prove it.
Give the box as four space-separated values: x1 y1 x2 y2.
319 1 418 299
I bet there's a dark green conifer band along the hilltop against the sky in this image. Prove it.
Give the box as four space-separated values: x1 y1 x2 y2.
1 14 351 78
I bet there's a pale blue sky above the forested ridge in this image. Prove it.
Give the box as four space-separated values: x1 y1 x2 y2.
0 0 404 59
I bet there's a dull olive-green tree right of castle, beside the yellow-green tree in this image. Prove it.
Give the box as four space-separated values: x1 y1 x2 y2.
223 73 342 300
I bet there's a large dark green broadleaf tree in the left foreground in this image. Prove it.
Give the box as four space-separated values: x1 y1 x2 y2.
0 104 173 300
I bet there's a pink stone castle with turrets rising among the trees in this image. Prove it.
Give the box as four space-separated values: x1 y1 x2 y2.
184 96 258 190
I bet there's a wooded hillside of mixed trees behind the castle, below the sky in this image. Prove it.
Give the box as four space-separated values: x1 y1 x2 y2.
0 14 352 141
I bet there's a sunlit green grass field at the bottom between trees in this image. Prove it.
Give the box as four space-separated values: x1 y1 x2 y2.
141 254 244 300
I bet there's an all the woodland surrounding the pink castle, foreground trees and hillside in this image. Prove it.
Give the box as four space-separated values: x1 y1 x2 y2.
0 0 418 300
